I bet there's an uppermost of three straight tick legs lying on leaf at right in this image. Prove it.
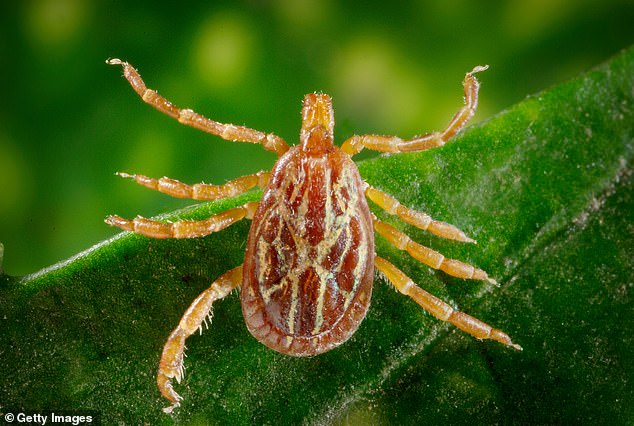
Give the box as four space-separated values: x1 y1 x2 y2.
365 186 476 243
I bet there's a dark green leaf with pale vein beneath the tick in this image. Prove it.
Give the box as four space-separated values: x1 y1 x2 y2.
0 49 634 424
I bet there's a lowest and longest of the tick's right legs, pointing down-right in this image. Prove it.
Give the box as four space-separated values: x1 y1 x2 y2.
374 256 522 350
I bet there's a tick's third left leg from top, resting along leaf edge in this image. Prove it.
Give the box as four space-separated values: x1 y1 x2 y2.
105 202 258 238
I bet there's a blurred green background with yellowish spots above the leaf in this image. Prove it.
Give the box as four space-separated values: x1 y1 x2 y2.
0 0 634 275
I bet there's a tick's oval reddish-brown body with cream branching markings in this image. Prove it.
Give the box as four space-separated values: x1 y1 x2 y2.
241 146 374 356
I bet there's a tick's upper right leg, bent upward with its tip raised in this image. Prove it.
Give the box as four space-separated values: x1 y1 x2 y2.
341 66 488 155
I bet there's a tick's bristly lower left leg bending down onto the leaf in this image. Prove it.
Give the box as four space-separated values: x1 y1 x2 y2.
156 266 242 413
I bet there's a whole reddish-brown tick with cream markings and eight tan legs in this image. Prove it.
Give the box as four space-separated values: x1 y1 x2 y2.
106 59 521 412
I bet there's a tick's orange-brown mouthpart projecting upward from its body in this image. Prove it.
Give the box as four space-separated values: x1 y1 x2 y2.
300 93 335 155
